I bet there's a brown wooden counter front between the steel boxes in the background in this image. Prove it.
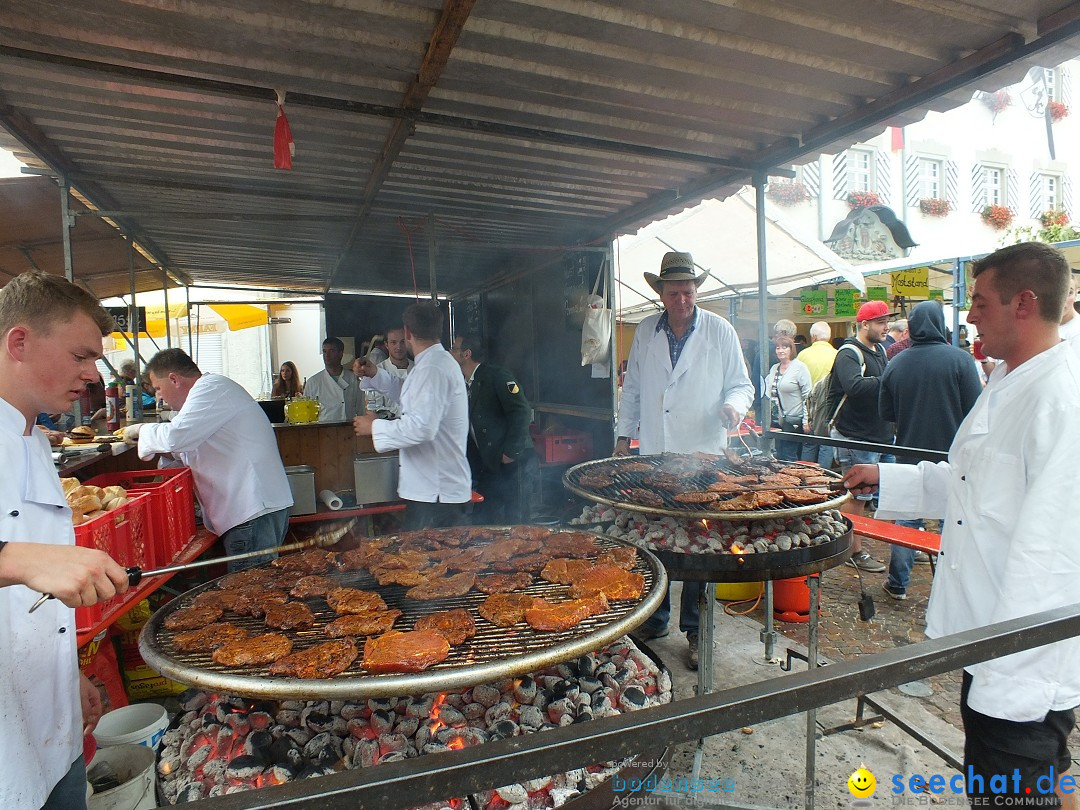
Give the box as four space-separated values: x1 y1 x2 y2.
273 422 375 494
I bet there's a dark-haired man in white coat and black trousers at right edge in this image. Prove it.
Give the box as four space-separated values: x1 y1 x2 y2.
845 242 1080 807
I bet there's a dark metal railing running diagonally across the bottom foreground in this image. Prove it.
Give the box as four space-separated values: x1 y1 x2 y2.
190 604 1080 810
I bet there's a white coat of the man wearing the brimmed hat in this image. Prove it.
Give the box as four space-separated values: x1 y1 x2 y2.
618 308 754 456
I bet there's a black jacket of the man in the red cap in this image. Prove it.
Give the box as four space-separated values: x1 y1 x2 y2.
828 338 892 444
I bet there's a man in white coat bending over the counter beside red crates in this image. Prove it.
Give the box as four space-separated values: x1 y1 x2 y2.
124 349 293 570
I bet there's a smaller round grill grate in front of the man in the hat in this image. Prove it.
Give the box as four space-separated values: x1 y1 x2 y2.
563 456 851 521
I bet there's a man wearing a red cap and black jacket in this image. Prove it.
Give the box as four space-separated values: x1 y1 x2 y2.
828 301 895 573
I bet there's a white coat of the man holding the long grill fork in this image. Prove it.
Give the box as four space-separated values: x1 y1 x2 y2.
0 400 82 810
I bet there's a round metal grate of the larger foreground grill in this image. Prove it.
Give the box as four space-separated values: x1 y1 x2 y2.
139 527 667 700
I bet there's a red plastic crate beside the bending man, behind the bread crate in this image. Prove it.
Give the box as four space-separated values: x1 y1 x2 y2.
86 467 195 567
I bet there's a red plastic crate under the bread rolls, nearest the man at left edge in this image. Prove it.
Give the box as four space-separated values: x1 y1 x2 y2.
75 494 153 631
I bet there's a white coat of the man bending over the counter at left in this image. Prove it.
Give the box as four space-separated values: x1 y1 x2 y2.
138 374 293 536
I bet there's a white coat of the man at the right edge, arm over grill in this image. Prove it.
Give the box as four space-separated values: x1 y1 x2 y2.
877 342 1080 721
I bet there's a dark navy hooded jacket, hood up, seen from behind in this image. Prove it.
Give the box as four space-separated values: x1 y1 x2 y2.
878 301 983 464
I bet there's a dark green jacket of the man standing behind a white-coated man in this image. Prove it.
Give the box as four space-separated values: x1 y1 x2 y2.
469 363 532 473
